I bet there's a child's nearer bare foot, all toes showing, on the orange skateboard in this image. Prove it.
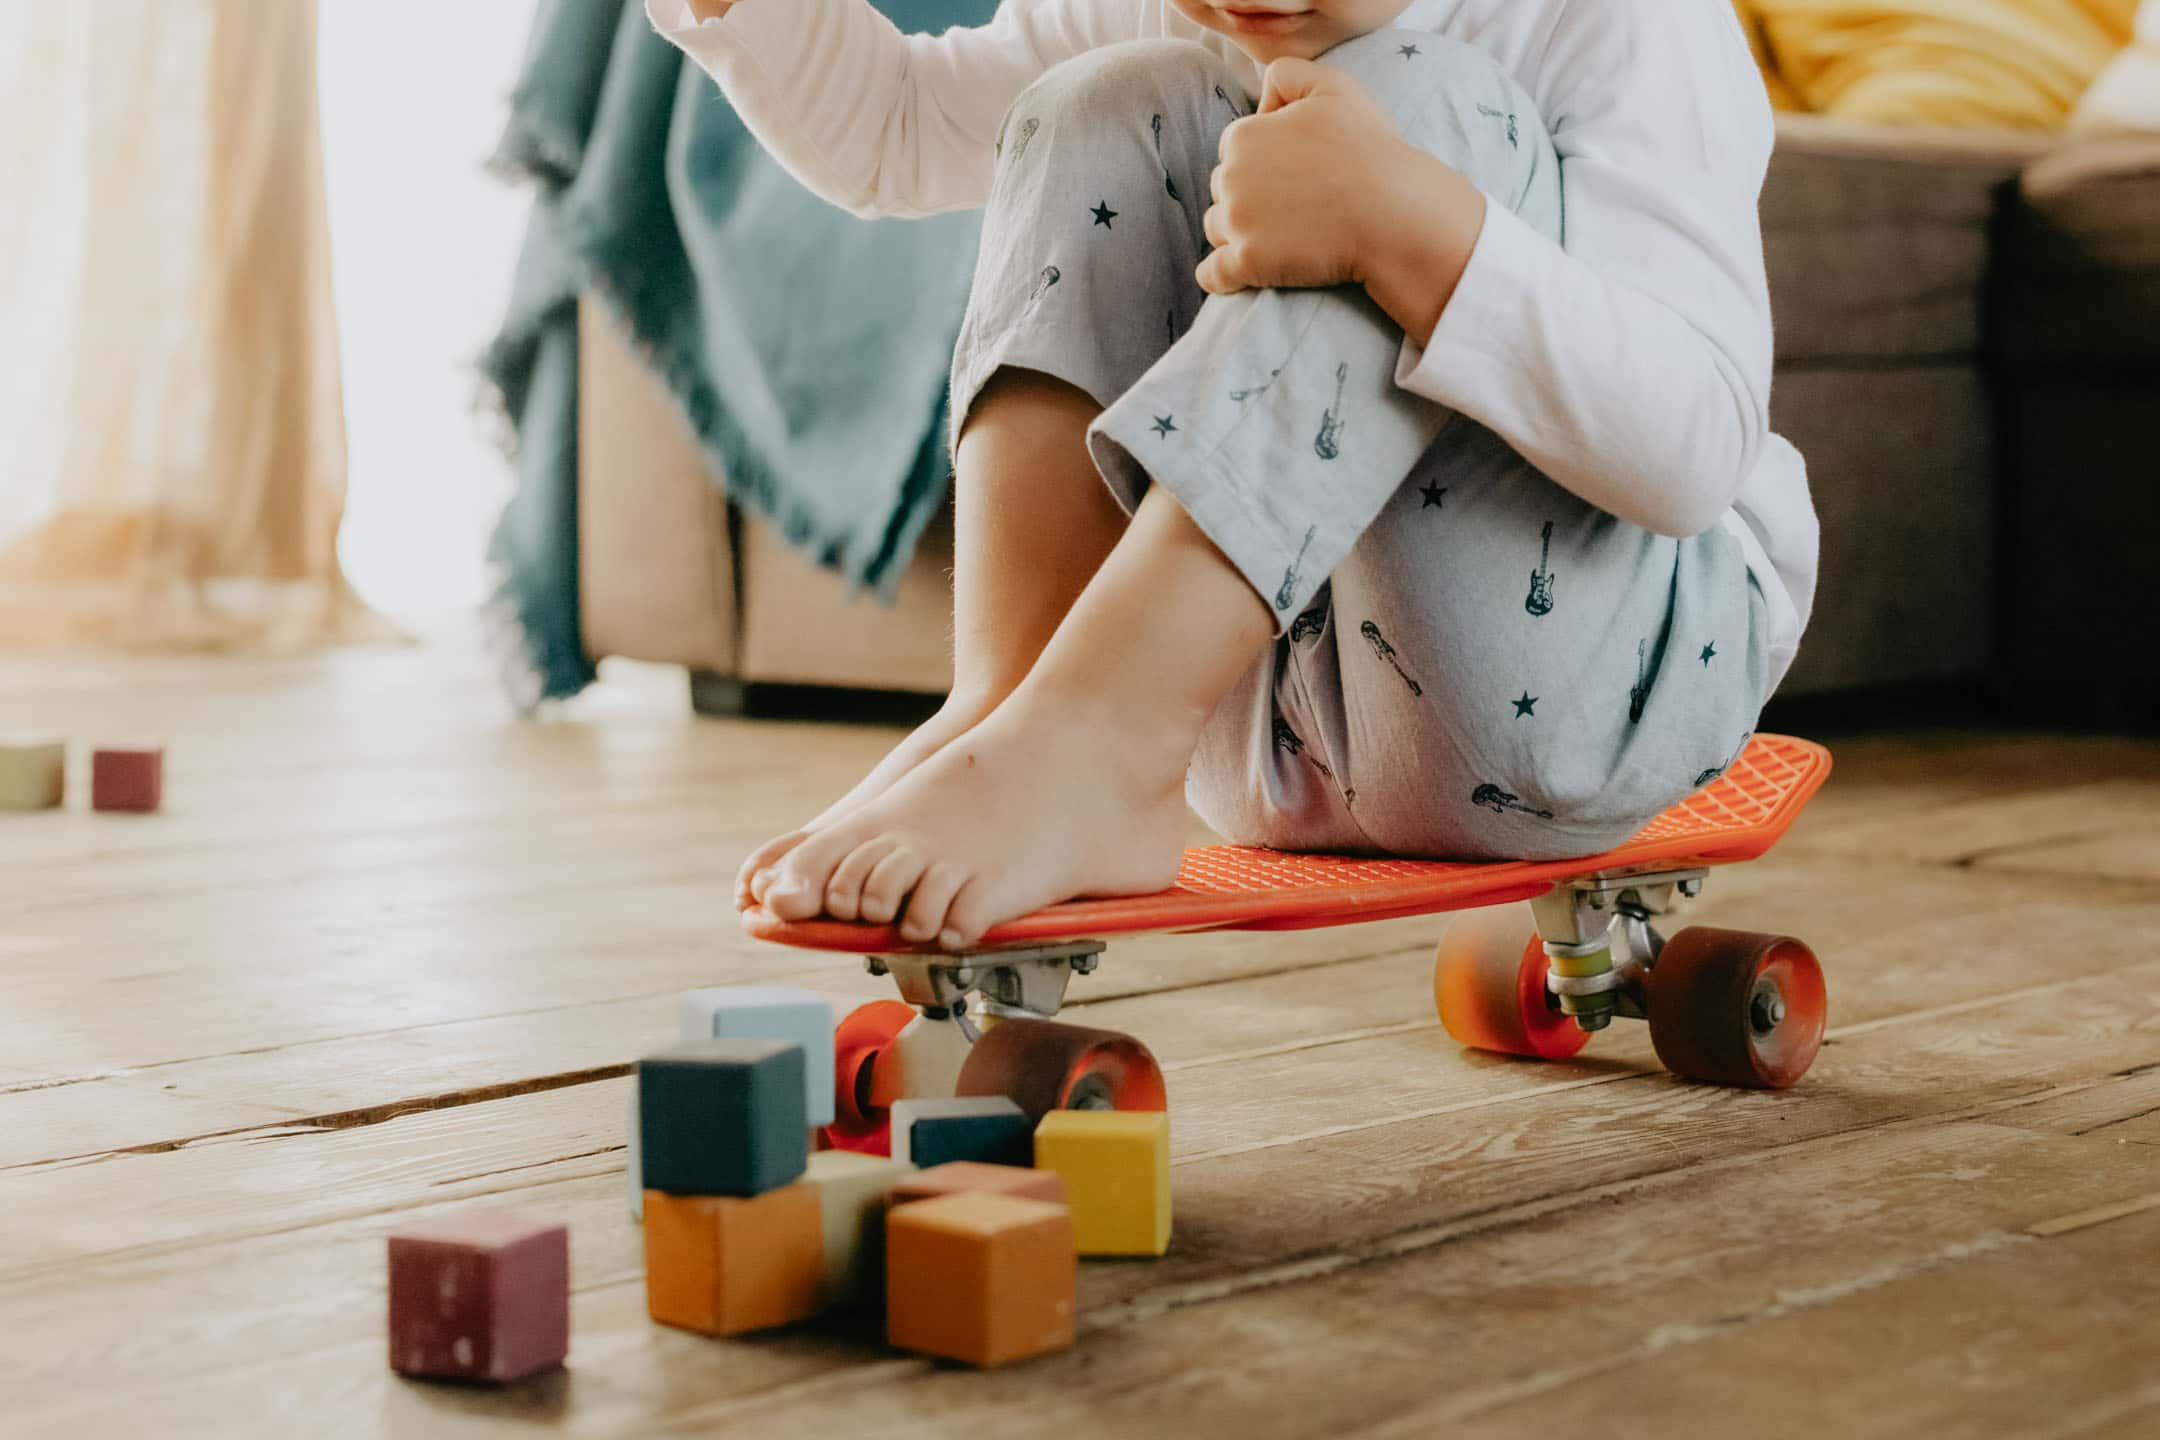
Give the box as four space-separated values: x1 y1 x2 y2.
758 687 1190 950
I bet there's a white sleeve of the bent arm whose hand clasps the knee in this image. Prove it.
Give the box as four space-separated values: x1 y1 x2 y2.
1395 0 1776 535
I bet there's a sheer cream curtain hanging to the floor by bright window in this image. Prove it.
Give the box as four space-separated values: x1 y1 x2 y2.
0 0 380 648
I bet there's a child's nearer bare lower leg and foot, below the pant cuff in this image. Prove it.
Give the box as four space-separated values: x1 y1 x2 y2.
765 472 1272 950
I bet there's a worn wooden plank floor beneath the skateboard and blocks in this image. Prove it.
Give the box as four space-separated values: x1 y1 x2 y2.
0 643 2160 1440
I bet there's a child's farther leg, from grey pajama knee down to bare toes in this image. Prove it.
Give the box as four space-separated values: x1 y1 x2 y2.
737 41 1246 906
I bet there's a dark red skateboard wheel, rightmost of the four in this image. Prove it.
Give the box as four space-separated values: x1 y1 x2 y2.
1648 926 1830 1090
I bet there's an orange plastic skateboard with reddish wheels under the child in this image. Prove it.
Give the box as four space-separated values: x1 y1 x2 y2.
743 734 1830 1151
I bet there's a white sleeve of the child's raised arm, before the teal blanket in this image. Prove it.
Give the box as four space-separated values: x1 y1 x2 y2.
646 0 1143 216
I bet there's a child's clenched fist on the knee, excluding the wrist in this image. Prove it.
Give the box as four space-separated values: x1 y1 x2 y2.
1197 58 1417 296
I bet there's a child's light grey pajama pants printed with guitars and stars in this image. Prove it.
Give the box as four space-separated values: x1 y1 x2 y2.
953 30 1767 859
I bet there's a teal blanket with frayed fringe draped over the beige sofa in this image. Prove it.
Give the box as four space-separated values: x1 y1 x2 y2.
482 0 994 706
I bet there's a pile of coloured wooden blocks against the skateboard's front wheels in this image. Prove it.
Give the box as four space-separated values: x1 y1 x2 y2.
631 987 1171 1367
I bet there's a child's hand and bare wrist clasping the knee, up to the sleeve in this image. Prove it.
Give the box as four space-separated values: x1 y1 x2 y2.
1197 58 1484 341
